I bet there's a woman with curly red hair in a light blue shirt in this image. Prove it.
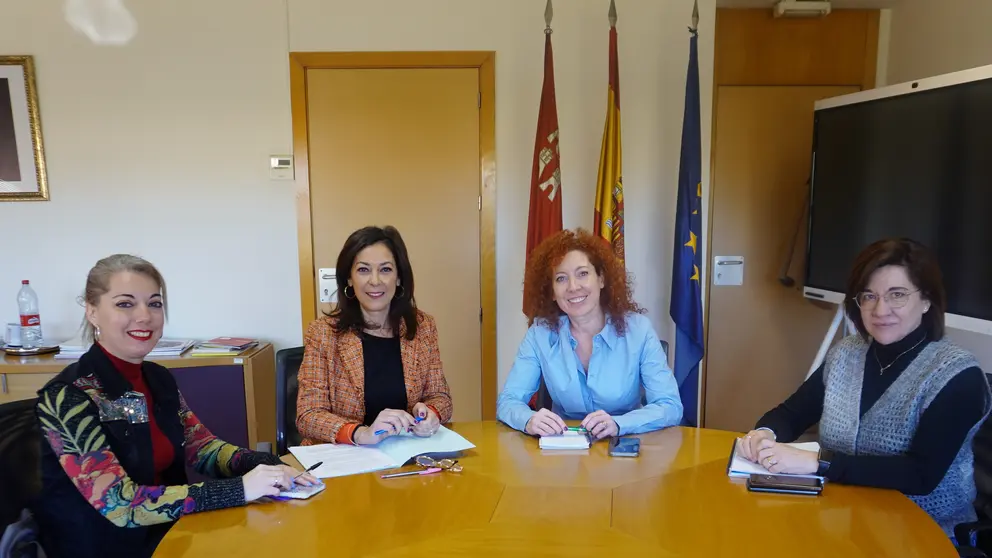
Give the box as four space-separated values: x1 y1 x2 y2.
496 229 682 440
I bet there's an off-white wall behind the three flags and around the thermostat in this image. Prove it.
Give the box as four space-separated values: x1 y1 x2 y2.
0 0 715 394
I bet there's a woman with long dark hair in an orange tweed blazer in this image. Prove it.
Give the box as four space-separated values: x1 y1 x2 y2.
296 227 452 445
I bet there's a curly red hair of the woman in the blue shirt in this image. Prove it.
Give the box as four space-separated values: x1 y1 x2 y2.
524 229 644 335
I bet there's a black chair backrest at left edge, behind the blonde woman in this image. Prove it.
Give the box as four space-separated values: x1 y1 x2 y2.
0 398 41 534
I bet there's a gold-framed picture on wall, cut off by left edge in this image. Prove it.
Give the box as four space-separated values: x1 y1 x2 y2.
0 56 48 202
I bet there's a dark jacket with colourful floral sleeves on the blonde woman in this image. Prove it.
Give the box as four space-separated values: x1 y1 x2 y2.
32 345 280 557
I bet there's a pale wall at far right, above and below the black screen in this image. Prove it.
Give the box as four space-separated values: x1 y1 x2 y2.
888 0 992 373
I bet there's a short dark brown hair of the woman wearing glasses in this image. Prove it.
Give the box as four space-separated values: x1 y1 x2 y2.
844 238 947 341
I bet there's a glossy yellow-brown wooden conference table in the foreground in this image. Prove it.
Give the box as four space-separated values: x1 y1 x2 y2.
155 422 957 558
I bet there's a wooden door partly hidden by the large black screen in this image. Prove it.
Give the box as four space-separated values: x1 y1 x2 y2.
705 86 860 432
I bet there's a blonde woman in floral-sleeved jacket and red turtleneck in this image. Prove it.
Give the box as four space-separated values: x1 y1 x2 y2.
32 254 319 557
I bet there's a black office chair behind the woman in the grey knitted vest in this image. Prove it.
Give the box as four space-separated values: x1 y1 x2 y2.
954 374 992 558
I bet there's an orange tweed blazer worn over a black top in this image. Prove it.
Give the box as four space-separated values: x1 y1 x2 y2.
296 310 452 445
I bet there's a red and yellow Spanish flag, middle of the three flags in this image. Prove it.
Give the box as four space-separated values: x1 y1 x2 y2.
593 0 624 261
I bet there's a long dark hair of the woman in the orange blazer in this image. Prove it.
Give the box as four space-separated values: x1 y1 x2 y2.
325 227 417 340
